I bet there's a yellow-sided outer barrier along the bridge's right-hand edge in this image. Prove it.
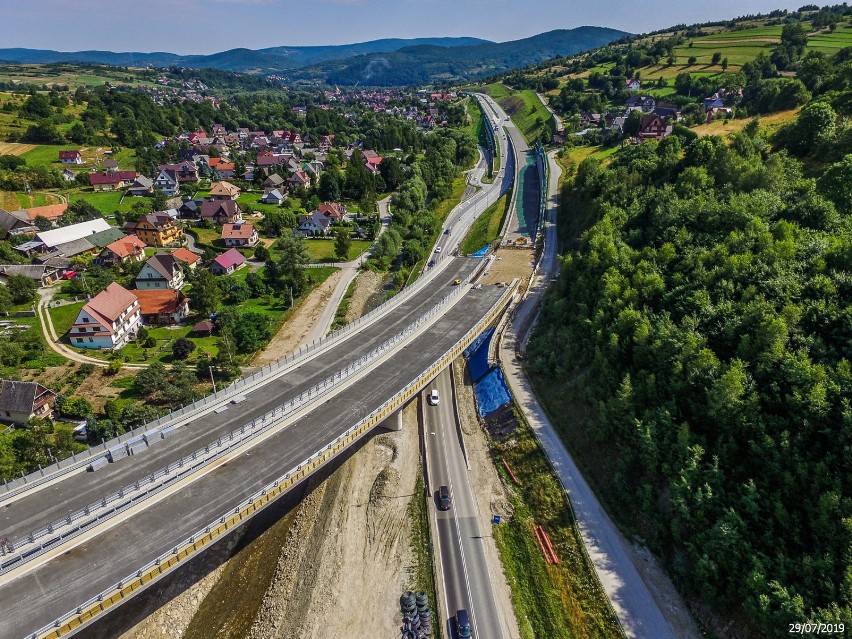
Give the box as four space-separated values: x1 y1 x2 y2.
27 280 517 639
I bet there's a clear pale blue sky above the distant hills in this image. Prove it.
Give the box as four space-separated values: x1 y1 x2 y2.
0 0 807 54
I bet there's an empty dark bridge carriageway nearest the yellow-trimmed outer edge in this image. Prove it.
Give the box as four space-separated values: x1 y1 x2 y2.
0 287 505 639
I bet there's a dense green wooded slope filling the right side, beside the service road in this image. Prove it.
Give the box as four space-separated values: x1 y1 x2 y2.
530 58 852 637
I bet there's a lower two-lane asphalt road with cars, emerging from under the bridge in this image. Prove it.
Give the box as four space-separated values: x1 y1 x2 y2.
423 370 504 639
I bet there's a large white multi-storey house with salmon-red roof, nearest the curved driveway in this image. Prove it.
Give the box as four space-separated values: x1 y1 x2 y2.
68 282 142 349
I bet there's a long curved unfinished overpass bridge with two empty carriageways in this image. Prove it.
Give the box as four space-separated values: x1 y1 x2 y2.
0 95 515 639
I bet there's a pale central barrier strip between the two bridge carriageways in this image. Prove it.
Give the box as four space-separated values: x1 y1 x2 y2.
0 286 472 575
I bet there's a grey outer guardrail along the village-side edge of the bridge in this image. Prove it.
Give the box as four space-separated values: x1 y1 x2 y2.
0 249 472 501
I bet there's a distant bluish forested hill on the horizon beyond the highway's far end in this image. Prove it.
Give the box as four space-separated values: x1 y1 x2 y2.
293 27 629 86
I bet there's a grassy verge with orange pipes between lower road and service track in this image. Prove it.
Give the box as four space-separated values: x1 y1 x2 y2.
493 415 624 639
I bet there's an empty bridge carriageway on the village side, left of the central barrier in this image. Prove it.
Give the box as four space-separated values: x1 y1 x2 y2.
0 258 479 552
